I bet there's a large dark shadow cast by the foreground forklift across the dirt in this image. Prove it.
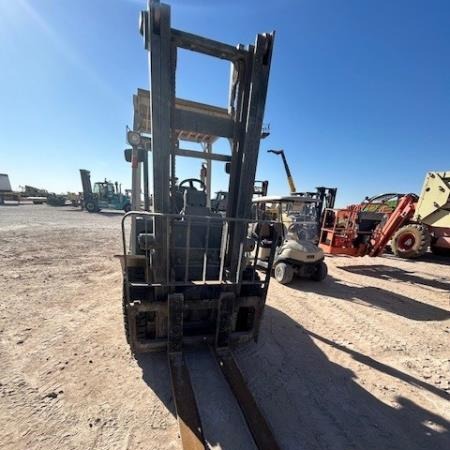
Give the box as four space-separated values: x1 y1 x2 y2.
137 307 450 450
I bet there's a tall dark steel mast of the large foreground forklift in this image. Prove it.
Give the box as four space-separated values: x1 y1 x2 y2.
129 1 274 267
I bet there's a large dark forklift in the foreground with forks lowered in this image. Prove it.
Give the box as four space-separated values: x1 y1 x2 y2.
119 0 279 450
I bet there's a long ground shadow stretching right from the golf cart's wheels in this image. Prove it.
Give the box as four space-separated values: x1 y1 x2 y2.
289 275 450 321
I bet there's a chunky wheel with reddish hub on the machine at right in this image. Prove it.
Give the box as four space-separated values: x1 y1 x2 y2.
391 223 431 259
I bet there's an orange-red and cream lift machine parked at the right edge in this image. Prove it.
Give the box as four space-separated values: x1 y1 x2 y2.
320 172 450 258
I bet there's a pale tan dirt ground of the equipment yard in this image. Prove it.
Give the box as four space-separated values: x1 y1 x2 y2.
0 205 450 450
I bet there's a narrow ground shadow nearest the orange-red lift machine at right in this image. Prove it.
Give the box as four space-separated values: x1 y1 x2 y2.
338 264 450 291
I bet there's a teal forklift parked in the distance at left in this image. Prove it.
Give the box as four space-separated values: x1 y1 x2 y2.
80 169 131 213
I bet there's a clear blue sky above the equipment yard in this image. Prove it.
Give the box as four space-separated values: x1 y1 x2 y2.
0 0 450 204
